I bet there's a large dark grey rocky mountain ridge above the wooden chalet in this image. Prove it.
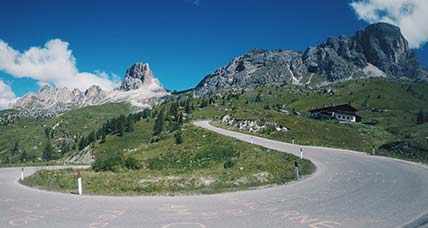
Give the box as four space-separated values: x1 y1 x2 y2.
194 23 427 96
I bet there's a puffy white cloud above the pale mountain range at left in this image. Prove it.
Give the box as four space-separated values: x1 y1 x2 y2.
0 39 117 90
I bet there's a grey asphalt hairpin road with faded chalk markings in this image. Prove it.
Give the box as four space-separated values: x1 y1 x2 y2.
0 121 428 228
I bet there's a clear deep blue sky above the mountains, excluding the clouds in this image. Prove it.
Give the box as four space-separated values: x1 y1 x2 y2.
0 0 428 96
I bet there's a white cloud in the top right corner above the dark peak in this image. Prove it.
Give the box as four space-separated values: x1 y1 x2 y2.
351 0 428 48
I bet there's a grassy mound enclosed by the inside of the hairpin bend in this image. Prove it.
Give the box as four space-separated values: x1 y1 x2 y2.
25 118 314 195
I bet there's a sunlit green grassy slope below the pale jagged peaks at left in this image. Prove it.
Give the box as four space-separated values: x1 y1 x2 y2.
0 104 130 164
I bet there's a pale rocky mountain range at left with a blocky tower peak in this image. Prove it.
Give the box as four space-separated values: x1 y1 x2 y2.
14 63 168 118
